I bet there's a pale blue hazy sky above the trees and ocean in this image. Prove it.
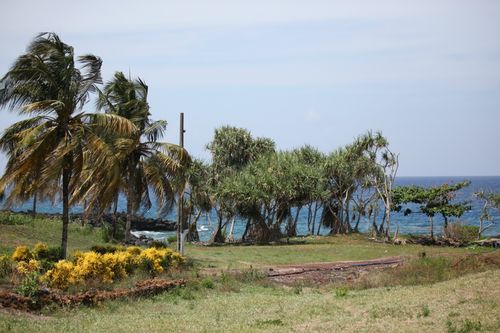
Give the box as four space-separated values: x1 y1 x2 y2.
0 0 500 176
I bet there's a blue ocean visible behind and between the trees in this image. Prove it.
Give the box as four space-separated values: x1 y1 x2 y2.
6 176 500 241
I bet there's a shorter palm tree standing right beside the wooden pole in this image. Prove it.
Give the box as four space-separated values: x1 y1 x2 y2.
97 72 190 241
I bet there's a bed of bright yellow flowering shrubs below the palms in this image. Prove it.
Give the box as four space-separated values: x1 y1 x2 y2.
4 243 185 290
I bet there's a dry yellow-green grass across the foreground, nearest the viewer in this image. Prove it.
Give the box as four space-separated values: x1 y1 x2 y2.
0 270 500 333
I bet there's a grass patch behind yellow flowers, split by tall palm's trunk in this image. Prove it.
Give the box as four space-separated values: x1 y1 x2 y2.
0 212 104 253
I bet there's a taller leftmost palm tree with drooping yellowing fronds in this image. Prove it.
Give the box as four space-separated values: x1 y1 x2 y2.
0 33 136 256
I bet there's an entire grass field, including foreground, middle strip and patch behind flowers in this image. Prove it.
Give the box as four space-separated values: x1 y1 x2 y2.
0 215 500 333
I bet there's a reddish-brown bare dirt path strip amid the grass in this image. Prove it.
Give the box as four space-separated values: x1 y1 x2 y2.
267 257 403 284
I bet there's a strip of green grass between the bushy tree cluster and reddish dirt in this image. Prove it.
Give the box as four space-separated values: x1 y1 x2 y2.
186 235 489 269
